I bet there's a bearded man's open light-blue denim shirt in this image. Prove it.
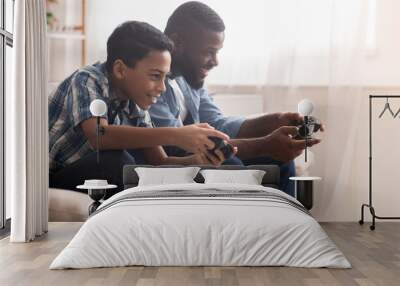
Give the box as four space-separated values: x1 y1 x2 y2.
149 76 245 138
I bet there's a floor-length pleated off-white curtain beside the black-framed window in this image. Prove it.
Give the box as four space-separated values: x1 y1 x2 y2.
6 0 48 242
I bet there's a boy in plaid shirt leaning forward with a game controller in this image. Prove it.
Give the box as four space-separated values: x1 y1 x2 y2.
49 21 236 197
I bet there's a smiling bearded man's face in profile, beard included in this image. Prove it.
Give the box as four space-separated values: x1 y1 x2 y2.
174 28 225 88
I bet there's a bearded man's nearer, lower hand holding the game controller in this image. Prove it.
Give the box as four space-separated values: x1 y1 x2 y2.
261 126 321 163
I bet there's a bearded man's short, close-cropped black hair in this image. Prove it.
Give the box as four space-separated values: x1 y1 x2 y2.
164 1 225 36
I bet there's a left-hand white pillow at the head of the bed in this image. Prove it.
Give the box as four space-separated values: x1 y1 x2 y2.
135 167 200 186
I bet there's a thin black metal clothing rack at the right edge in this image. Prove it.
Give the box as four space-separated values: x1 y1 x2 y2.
358 95 400 230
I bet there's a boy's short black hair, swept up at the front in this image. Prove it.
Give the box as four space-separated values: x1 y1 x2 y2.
106 21 173 71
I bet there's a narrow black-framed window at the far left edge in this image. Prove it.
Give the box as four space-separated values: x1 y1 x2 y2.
0 0 14 232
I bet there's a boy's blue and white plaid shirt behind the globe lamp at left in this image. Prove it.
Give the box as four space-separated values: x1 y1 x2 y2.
49 63 152 173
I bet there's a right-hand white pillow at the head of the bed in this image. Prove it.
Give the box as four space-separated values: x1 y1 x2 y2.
200 170 265 185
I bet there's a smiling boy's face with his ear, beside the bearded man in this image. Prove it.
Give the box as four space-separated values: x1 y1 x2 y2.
113 51 171 110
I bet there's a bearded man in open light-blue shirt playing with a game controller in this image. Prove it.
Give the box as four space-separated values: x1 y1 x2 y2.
149 1 319 195
